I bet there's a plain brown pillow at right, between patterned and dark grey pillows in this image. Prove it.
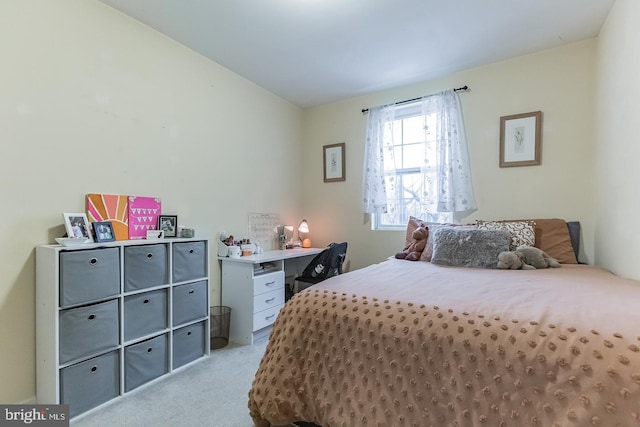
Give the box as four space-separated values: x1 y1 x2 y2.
533 218 578 264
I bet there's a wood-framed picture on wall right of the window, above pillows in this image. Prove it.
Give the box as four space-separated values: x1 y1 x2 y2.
500 111 542 168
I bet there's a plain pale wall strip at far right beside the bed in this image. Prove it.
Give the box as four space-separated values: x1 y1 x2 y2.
594 0 640 279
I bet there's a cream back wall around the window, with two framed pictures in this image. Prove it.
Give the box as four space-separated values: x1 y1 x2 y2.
303 39 596 269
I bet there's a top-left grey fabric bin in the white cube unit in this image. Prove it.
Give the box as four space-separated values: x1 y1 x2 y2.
60 248 120 307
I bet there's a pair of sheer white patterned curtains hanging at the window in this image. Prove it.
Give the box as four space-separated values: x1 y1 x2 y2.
362 90 477 214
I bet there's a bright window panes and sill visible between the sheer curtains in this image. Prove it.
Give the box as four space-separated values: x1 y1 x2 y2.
372 102 452 230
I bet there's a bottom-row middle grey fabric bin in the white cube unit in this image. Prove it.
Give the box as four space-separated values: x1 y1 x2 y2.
124 335 169 391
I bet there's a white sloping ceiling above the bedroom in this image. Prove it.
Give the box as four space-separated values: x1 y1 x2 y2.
100 0 615 108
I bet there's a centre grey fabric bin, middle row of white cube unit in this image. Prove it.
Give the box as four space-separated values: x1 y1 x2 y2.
124 289 169 341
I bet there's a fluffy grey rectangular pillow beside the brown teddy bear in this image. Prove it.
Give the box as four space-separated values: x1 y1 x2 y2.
431 227 511 268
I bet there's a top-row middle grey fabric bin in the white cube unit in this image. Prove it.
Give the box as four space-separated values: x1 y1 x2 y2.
124 243 169 291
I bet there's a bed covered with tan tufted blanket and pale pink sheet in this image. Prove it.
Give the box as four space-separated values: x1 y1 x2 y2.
249 219 640 427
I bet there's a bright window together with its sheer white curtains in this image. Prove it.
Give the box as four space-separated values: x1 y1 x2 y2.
362 90 476 229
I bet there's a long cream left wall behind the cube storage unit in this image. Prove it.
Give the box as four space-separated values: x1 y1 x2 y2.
0 0 302 403
